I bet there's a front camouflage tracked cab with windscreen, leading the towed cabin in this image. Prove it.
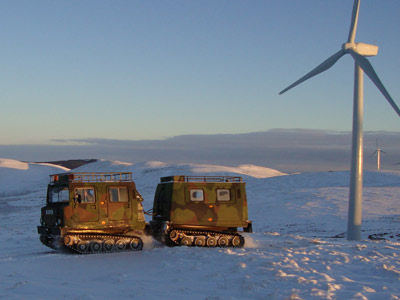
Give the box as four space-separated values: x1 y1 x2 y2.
38 172 146 253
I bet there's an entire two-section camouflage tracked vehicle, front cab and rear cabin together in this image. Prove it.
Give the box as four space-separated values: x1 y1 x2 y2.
38 172 252 253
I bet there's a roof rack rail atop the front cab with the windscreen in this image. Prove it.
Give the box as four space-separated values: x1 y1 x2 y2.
50 172 132 183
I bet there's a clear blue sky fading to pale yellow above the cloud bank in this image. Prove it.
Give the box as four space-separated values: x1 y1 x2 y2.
0 0 400 145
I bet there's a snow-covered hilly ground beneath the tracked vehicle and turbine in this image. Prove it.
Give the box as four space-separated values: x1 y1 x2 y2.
0 159 400 300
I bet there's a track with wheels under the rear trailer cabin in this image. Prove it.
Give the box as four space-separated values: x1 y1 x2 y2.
166 229 245 248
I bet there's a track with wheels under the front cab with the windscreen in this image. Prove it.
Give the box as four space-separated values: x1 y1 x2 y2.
64 234 143 254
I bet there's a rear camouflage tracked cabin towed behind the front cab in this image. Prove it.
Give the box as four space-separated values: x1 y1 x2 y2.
150 176 252 247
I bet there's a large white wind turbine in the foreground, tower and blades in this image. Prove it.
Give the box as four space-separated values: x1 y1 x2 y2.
279 0 400 241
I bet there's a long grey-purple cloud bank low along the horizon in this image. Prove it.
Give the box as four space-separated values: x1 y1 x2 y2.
0 129 400 173
